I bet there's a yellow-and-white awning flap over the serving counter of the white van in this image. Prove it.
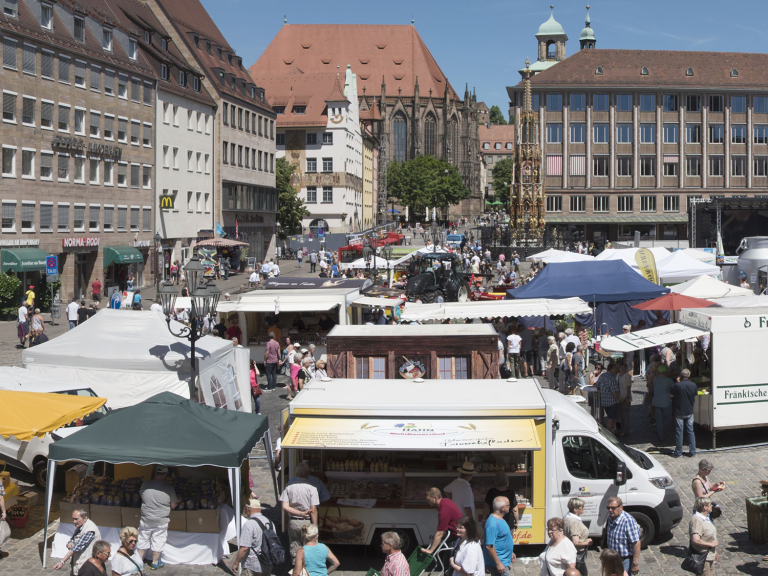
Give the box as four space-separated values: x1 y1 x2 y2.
282 418 541 451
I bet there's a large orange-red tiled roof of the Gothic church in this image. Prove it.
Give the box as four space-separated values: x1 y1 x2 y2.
249 24 459 100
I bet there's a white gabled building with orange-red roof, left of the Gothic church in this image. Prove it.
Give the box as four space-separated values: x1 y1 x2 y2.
259 65 363 232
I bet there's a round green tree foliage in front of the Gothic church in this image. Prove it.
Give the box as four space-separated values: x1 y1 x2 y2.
387 156 469 214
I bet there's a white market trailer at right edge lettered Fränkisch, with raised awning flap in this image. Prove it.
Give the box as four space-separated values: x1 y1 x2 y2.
600 307 768 448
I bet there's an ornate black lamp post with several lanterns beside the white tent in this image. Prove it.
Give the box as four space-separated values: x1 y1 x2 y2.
159 256 221 400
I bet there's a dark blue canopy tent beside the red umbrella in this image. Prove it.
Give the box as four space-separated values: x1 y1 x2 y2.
507 260 669 334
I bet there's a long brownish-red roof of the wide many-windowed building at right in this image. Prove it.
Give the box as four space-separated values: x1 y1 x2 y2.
521 49 768 89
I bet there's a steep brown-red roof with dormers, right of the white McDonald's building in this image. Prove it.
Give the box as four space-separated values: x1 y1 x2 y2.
157 0 272 112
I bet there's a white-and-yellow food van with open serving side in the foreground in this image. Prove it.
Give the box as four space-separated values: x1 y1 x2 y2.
282 379 683 550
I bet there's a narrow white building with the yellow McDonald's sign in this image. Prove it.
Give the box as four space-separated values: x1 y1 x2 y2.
155 67 215 279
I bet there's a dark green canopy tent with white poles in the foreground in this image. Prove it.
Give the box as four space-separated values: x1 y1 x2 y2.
43 392 278 568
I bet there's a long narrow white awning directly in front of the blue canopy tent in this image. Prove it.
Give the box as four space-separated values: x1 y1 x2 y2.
401 298 592 322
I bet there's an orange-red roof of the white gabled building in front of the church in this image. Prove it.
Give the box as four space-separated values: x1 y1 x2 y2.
261 73 346 128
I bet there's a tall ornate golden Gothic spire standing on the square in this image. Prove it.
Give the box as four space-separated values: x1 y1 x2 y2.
510 59 545 240
